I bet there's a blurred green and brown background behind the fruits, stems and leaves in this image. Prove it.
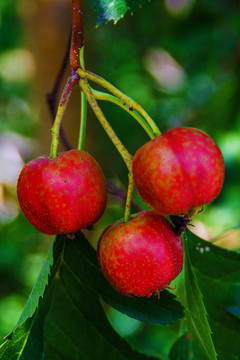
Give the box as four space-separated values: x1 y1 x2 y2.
0 0 240 358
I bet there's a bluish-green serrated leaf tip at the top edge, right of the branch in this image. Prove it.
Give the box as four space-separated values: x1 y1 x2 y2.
95 0 146 24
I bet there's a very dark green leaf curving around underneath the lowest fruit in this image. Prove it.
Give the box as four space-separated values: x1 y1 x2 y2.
66 231 184 324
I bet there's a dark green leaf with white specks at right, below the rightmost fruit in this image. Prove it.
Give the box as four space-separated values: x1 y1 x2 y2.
187 231 240 314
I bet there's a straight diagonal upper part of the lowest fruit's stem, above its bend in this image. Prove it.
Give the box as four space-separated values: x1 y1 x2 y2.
79 79 132 172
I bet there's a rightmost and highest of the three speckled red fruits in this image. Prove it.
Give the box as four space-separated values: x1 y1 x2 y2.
133 127 224 216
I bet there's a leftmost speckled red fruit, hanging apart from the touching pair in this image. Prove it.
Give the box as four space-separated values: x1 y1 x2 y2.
17 150 107 235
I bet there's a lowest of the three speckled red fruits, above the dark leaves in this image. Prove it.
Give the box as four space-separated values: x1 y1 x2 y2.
98 211 183 297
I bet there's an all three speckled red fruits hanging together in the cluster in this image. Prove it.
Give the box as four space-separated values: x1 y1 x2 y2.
17 127 224 297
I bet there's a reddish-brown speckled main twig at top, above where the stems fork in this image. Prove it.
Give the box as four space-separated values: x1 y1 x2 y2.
70 0 84 71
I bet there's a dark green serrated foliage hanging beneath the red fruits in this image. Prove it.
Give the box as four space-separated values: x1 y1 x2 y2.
1 226 240 359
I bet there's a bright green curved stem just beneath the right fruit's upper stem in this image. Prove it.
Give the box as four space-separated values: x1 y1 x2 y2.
91 88 155 139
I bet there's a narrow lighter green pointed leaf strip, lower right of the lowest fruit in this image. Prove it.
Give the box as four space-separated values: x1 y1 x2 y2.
184 232 217 360
